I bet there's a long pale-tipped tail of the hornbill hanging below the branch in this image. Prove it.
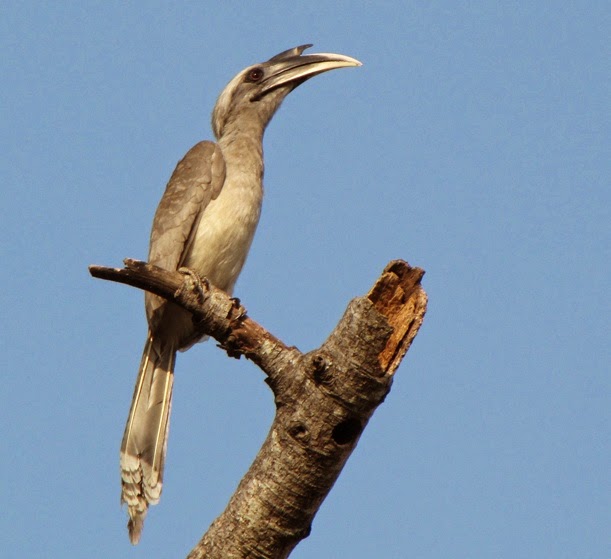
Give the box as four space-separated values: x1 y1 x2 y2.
121 332 176 545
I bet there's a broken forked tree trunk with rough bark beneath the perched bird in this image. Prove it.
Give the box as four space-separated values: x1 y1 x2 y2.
89 260 427 559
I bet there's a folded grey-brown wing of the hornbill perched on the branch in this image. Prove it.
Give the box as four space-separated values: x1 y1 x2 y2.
147 142 225 318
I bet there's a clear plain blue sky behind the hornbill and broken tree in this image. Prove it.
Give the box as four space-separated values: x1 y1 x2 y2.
0 2 611 559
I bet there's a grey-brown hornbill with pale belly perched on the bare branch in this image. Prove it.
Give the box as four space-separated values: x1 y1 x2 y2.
120 44 362 545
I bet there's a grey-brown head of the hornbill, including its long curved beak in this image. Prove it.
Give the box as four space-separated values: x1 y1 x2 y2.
212 45 361 139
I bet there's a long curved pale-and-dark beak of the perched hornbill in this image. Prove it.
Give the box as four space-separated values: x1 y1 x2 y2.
253 45 362 101
